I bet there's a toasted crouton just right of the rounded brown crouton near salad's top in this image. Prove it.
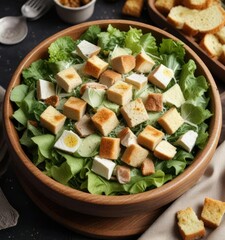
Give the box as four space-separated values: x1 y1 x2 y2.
134 52 155 73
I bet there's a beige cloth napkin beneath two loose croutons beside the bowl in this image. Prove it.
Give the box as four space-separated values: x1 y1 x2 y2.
139 141 225 240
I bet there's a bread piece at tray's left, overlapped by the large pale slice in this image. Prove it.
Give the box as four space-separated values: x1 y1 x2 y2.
167 5 197 29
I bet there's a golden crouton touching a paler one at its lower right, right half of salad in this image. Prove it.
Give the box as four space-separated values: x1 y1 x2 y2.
137 125 164 151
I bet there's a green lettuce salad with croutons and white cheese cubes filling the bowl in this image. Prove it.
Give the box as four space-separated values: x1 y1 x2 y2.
10 25 212 195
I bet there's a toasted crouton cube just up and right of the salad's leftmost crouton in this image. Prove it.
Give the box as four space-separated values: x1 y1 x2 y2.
63 97 87 120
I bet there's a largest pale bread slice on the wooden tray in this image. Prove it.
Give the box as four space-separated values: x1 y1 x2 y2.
183 4 225 36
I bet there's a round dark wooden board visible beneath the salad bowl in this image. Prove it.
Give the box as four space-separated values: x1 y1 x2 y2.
17 172 166 239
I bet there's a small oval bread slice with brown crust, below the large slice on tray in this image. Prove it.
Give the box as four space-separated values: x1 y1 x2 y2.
199 33 223 58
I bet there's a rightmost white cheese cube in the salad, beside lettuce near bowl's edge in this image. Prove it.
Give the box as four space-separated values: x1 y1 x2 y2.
177 130 198 152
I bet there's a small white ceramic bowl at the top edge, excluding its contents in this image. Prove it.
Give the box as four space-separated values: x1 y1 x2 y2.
54 0 96 24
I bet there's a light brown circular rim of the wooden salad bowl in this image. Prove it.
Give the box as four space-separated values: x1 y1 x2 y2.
4 19 222 205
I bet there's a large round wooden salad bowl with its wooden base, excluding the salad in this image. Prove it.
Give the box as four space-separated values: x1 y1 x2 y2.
4 20 222 238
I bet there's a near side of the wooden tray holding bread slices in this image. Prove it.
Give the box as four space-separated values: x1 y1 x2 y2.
148 0 225 82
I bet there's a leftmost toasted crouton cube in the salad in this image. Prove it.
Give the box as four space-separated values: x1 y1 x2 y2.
40 106 66 134
